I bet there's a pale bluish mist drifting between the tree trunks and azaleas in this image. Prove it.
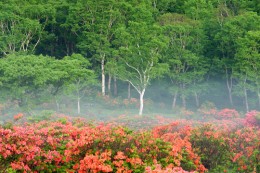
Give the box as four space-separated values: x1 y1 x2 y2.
0 76 259 128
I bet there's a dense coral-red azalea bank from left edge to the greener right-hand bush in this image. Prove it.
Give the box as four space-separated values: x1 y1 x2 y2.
0 118 200 173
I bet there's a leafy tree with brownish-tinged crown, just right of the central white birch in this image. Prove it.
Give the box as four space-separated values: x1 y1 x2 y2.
158 13 207 108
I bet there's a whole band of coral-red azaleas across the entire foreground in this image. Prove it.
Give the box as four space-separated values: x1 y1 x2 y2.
0 111 260 173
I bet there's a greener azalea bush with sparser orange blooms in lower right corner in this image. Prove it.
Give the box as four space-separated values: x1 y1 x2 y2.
191 124 260 172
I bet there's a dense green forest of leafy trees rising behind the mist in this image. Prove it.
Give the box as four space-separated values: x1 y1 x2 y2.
0 0 260 114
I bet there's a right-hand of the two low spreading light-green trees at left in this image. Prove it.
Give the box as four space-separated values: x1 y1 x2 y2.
48 54 95 113
